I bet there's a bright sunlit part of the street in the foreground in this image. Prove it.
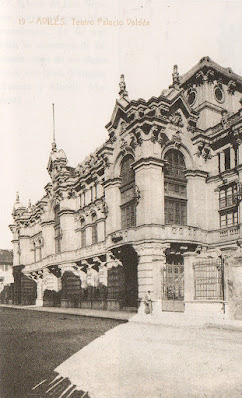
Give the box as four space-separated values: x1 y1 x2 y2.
43 322 241 398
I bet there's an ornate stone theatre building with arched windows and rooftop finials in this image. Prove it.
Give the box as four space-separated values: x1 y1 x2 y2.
10 57 242 319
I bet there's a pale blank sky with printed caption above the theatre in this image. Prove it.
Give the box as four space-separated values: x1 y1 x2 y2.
0 0 242 249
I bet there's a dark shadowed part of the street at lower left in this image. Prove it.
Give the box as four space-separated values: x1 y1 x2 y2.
0 308 124 398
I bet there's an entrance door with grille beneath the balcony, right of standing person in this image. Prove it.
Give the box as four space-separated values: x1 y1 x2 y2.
162 261 185 312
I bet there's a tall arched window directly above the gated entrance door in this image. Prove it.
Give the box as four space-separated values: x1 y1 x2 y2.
164 149 187 225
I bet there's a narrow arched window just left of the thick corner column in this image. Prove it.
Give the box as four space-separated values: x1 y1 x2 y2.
120 155 136 228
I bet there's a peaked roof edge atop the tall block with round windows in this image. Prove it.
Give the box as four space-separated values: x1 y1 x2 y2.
180 57 242 84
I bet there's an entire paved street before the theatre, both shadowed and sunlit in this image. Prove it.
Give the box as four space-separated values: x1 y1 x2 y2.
0 309 242 398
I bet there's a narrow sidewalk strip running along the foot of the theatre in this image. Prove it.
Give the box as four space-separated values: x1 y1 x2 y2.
0 304 242 331
